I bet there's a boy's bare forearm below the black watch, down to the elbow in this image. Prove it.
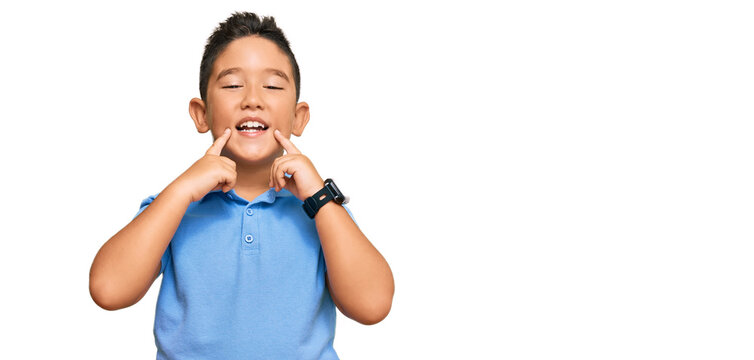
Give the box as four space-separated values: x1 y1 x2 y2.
314 202 395 324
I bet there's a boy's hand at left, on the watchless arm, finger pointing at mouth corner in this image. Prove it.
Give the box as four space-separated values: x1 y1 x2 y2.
169 128 237 202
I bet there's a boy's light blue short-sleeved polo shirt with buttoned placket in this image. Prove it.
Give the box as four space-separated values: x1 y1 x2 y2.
135 188 353 359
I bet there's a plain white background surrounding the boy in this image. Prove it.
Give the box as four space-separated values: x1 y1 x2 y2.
0 1 754 359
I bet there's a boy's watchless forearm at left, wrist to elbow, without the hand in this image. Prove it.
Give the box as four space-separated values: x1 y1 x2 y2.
89 186 191 310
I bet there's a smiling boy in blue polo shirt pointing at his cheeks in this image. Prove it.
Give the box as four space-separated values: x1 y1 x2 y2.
89 13 394 359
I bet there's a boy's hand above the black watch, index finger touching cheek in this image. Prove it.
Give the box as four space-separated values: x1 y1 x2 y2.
270 129 325 201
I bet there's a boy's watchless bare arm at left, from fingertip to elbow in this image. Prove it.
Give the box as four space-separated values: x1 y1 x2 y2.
89 129 237 310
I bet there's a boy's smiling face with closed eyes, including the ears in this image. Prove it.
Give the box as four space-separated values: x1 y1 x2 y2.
190 36 309 163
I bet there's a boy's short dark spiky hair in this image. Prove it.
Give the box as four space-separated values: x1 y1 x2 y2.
199 12 301 101
